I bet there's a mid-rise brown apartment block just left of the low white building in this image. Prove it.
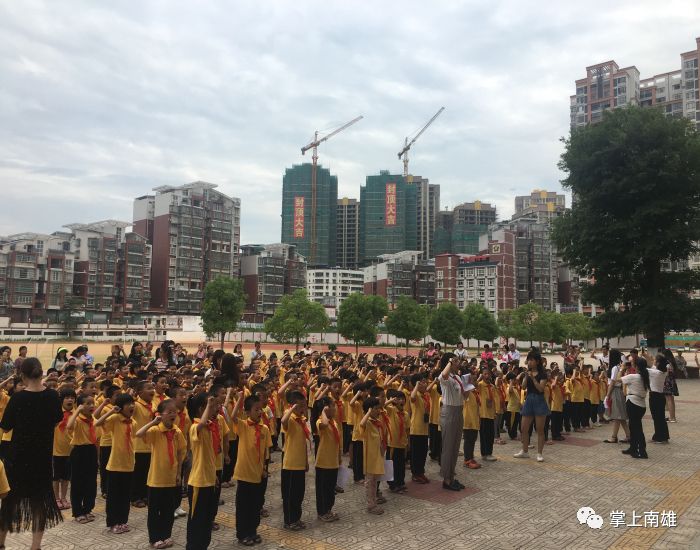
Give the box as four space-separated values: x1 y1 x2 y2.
241 243 307 322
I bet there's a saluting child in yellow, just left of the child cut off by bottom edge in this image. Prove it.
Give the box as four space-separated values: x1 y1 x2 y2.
136 399 187 548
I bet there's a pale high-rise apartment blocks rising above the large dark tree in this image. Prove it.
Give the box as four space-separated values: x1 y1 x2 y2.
570 38 700 128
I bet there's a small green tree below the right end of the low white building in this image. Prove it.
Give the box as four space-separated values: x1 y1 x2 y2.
337 292 389 354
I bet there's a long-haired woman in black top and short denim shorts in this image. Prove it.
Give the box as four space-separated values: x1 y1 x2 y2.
513 351 549 462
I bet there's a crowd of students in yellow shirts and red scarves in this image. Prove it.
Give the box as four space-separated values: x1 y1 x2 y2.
0 341 675 549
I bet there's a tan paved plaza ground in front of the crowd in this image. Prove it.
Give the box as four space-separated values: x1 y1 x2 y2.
7 380 700 550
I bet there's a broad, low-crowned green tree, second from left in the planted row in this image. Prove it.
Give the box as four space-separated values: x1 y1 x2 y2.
265 289 331 351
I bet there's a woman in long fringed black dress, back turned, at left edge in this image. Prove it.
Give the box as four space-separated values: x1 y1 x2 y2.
0 357 63 550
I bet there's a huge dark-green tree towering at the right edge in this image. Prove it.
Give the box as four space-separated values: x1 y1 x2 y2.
554 107 700 347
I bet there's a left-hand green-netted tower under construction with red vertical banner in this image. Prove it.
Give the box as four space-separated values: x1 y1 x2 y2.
282 163 338 267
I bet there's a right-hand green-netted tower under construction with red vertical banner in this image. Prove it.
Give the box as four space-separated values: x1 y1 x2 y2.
360 170 422 266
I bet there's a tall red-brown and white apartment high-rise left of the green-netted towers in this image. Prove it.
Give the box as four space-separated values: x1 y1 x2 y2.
134 181 241 315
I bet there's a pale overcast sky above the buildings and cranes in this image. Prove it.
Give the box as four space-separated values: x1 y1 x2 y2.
0 0 700 243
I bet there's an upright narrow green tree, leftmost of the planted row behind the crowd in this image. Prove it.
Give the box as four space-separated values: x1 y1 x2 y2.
201 275 246 349
